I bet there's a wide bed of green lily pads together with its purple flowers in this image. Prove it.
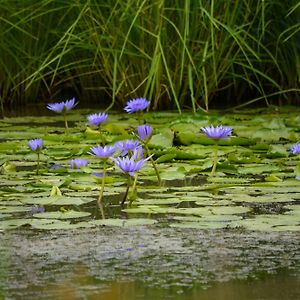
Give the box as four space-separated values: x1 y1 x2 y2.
0 98 300 230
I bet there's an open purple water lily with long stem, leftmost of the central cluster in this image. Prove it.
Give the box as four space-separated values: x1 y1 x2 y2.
88 145 116 219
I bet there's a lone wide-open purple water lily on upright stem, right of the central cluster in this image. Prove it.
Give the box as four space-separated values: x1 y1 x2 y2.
201 125 232 176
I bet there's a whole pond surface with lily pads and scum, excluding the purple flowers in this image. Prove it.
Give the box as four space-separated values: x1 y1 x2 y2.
0 108 300 300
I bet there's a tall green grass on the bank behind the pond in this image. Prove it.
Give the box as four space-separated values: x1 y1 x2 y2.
0 0 300 112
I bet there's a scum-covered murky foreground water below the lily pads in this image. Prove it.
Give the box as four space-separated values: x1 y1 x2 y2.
0 227 300 300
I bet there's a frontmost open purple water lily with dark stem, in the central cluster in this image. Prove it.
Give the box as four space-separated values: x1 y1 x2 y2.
111 147 151 206
